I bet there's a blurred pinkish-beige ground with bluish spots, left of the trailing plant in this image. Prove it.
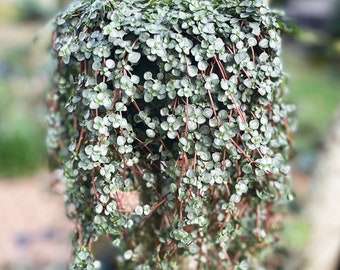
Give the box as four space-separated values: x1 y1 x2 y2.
0 172 72 270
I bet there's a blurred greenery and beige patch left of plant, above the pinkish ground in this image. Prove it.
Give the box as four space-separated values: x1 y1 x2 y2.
0 0 63 177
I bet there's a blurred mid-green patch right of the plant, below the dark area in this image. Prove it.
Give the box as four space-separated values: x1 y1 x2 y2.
284 49 340 153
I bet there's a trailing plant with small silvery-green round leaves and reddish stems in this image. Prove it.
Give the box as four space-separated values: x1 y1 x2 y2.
48 0 292 269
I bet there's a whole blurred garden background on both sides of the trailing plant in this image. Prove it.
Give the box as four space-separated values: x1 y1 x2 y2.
0 0 340 270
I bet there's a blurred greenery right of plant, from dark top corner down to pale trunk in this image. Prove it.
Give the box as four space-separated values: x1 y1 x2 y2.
272 0 340 173
